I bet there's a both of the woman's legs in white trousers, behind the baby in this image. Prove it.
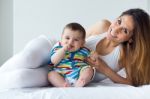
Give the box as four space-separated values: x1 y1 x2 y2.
0 35 56 88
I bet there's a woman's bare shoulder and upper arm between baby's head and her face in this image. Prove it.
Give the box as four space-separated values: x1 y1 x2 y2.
86 19 111 38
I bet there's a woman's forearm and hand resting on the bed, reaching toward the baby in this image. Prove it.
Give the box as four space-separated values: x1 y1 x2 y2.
87 58 132 85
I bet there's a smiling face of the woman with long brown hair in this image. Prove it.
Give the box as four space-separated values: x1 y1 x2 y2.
107 15 134 43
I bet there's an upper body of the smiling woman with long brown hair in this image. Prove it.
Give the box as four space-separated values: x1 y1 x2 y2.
87 9 150 86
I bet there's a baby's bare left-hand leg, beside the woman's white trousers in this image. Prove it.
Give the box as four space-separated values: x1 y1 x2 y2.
48 71 70 87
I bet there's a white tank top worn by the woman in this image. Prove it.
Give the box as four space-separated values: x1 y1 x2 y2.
85 33 120 82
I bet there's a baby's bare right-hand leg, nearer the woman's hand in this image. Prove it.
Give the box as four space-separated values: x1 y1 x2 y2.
75 67 94 87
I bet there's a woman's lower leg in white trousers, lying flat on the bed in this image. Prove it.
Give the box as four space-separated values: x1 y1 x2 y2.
0 67 48 89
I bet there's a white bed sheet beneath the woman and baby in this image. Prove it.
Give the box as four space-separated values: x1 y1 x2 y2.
0 81 150 99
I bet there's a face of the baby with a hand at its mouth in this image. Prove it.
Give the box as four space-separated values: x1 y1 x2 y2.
61 28 85 52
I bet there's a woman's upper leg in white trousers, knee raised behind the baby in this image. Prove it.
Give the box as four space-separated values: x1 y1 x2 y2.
1 35 56 70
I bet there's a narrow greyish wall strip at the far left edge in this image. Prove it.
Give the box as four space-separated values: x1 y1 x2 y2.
0 0 13 65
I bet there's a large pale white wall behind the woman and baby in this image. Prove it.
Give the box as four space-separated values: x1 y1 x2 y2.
14 0 148 53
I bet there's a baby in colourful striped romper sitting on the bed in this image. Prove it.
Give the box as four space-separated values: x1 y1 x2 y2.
48 23 94 87
